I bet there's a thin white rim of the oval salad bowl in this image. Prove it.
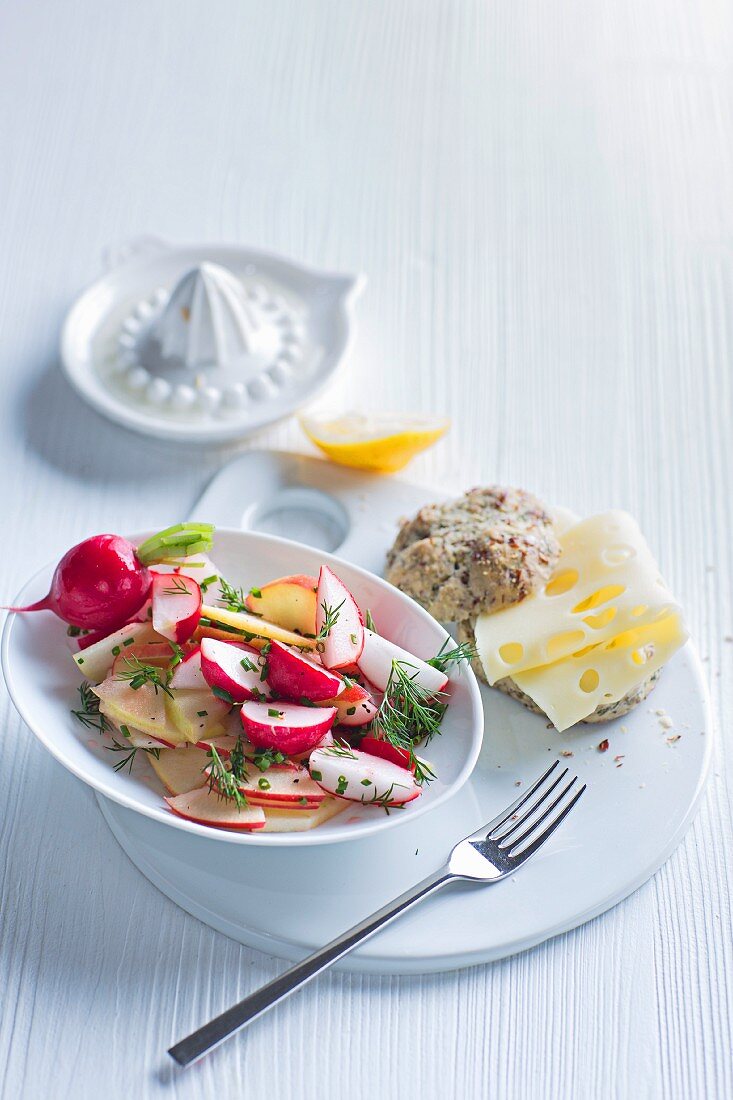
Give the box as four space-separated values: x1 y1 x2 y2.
0 527 484 848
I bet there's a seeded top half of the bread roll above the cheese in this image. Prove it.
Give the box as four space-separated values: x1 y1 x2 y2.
386 485 560 623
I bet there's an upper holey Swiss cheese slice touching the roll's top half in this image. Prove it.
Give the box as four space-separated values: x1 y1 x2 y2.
475 512 680 682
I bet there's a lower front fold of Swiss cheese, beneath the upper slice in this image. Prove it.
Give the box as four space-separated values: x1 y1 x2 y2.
512 613 687 730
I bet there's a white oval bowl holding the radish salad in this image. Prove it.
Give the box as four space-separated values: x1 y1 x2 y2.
2 529 483 847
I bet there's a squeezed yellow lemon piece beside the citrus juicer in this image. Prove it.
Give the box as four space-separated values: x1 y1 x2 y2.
300 413 450 474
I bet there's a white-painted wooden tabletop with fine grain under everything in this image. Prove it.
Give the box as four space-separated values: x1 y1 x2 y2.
0 0 733 1100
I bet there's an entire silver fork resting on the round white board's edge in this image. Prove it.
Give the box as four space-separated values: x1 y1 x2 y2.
168 760 586 1066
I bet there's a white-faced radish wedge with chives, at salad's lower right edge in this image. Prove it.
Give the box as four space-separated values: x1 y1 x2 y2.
308 745 420 806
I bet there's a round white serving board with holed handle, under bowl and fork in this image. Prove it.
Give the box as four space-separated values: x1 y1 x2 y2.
1 452 712 974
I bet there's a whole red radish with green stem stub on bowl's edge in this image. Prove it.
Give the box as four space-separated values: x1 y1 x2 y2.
7 524 214 634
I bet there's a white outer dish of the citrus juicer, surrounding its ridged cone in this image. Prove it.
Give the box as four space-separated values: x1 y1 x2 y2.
61 238 364 443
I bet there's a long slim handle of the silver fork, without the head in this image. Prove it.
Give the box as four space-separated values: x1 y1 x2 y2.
168 867 455 1066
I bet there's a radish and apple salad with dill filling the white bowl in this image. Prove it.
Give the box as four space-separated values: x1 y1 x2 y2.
11 524 473 832
